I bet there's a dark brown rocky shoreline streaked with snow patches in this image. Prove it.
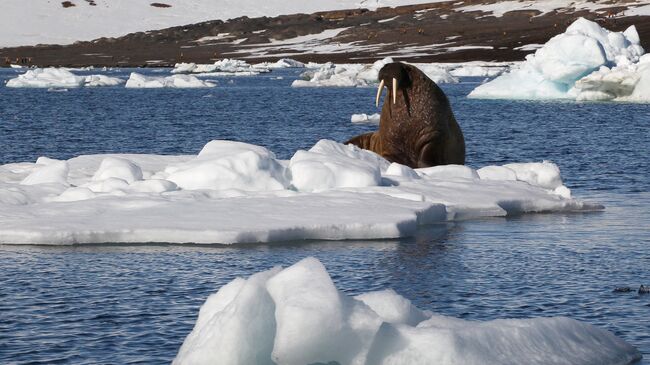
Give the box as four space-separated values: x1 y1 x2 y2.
0 0 650 67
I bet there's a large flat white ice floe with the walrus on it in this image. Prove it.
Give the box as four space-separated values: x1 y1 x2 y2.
0 140 602 244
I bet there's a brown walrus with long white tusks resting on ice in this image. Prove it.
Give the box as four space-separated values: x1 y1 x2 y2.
345 62 465 168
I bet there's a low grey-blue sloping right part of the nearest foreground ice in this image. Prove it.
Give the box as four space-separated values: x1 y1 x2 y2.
366 316 641 365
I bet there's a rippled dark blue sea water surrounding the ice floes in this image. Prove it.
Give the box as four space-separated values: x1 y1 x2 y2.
0 70 650 364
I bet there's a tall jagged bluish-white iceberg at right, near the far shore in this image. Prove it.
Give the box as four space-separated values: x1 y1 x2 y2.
469 18 650 102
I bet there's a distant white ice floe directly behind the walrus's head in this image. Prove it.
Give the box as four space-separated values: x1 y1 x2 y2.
291 57 458 87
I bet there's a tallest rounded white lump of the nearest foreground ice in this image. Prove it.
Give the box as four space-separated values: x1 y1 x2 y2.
266 258 381 365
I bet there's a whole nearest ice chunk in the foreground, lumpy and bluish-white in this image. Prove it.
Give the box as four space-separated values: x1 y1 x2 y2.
173 257 641 365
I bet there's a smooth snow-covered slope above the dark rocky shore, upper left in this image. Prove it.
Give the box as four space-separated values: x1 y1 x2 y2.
0 0 436 47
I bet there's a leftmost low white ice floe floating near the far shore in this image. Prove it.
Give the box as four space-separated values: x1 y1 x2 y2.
7 67 124 89
